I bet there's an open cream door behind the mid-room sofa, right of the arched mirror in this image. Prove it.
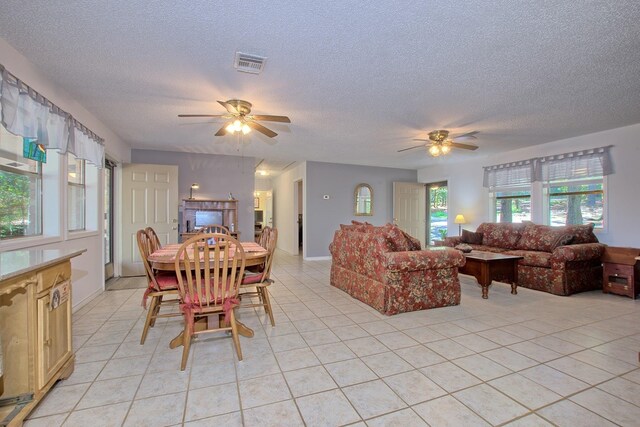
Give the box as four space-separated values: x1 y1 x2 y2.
393 182 427 247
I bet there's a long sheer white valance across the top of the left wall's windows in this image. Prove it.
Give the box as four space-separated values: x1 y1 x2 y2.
0 65 104 168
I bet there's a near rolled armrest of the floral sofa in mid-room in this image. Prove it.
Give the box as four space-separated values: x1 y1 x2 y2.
383 248 465 271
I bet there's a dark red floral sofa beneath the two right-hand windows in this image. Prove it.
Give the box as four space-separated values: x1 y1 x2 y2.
444 222 605 295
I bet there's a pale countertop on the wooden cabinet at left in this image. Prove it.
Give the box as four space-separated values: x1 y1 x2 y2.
0 249 87 280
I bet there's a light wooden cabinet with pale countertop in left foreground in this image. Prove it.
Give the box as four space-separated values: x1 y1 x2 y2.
0 250 84 426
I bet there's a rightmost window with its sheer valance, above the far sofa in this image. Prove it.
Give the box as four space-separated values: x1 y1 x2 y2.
536 147 613 229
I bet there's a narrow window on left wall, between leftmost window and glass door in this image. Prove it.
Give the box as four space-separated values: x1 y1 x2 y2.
67 154 86 231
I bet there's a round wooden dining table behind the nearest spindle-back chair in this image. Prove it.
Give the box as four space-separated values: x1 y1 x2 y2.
148 242 269 348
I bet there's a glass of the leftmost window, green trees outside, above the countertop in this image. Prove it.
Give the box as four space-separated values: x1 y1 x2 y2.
0 126 42 239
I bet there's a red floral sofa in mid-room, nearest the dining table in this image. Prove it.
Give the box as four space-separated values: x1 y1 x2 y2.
329 224 465 315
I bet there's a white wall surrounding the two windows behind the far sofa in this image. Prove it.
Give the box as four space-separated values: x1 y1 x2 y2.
418 124 640 247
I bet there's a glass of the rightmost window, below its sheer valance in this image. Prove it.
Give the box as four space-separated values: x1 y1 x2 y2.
549 182 604 228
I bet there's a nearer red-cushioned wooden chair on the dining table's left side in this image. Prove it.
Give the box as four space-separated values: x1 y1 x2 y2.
136 230 180 345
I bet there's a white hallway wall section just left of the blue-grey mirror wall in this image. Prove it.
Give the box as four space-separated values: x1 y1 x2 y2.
271 162 307 255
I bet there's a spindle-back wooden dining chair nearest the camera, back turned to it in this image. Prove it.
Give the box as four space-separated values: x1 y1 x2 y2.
175 233 246 371
